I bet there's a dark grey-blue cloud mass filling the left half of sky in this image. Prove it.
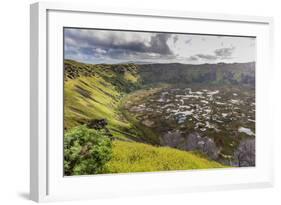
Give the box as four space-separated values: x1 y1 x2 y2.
64 29 173 59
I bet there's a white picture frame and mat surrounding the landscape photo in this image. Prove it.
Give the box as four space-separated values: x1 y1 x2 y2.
30 2 273 202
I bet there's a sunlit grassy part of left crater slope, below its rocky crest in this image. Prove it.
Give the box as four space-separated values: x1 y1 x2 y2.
64 64 141 139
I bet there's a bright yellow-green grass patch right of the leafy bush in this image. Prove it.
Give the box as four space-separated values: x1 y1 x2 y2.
106 141 224 173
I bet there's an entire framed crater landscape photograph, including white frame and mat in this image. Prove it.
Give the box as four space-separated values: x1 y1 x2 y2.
30 3 273 202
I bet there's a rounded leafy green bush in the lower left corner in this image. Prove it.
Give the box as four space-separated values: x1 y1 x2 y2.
64 125 112 176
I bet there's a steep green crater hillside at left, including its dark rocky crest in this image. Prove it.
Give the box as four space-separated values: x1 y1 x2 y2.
64 60 142 139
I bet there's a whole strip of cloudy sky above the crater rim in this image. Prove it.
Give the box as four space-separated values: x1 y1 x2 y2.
64 28 256 64
